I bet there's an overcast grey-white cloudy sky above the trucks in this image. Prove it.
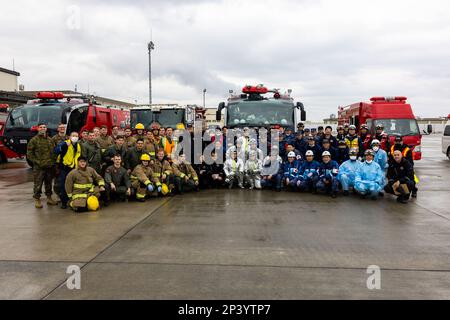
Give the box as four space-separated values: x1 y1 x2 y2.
0 0 450 120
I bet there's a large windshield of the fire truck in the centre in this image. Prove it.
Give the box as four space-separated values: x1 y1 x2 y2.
227 100 294 127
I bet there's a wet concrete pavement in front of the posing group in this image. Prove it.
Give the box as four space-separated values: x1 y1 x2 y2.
0 136 450 299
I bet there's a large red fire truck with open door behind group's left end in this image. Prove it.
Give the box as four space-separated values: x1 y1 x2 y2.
1 92 130 161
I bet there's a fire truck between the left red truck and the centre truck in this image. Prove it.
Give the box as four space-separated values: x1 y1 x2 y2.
130 104 198 129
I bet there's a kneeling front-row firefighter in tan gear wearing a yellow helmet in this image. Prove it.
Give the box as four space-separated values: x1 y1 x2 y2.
130 153 155 202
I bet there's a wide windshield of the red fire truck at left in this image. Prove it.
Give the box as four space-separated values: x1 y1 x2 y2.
5 104 67 131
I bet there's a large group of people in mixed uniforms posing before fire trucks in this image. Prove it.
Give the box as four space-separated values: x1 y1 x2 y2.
27 123 417 211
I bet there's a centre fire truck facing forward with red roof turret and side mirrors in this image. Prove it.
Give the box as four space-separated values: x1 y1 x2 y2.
216 85 306 128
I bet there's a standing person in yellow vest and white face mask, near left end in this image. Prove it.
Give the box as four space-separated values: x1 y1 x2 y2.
55 132 81 209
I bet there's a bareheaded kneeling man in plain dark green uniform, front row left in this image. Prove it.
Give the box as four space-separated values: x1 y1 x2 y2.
105 154 131 206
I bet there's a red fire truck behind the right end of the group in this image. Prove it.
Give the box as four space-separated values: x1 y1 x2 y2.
338 97 422 160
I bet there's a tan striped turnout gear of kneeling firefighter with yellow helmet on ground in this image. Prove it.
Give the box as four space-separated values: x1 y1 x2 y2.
65 167 105 210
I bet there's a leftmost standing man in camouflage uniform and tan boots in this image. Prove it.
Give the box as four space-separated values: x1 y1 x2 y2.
27 123 57 209
